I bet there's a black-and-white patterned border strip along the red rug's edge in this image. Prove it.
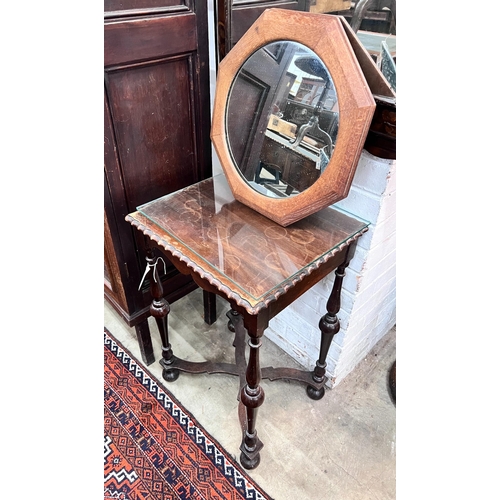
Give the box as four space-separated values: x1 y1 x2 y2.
104 327 273 500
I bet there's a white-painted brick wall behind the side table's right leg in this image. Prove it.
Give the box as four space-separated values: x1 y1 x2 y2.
266 151 396 386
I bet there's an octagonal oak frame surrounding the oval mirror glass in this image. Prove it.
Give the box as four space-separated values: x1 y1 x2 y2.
211 8 375 226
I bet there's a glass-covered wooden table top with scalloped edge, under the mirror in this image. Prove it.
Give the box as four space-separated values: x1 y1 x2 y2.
126 174 369 314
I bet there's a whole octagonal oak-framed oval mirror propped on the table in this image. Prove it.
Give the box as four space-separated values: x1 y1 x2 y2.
211 9 375 226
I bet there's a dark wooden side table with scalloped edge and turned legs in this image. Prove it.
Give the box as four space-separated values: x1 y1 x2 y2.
126 174 368 469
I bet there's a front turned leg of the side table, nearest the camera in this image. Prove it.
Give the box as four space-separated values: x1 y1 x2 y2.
240 316 264 469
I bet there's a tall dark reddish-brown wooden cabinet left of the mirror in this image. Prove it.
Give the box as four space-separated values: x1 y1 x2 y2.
104 0 212 364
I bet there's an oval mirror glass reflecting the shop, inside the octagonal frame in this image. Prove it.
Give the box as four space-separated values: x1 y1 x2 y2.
226 41 339 198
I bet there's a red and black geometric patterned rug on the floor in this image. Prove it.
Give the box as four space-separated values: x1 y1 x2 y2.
104 329 271 500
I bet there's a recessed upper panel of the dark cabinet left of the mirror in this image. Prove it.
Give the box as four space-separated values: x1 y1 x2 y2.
107 57 199 211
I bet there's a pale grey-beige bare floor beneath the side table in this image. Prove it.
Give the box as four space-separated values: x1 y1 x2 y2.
104 290 396 500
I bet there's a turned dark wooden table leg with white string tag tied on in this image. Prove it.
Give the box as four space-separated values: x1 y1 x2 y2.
146 250 179 382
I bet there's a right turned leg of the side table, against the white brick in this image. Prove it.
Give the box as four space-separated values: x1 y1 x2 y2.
306 243 356 400
